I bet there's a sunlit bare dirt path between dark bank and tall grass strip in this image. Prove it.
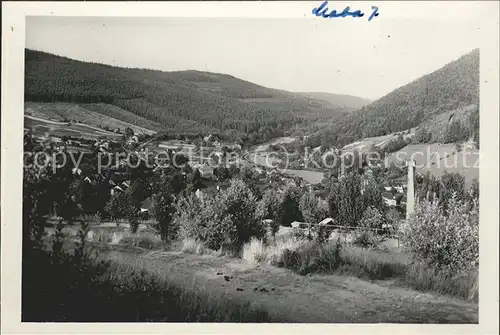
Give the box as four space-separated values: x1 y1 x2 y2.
103 252 478 323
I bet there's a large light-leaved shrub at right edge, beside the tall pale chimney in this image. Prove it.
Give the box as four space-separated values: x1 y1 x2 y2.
403 195 479 273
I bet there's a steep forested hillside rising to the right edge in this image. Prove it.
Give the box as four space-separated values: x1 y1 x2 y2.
306 49 479 146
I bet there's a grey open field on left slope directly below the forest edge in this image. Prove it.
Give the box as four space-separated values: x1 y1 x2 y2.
25 102 155 135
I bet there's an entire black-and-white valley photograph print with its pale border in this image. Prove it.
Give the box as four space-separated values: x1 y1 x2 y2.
1 1 498 330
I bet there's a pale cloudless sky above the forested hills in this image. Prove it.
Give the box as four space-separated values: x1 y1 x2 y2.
26 16 479 100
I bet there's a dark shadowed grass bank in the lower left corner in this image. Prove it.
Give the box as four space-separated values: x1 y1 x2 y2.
22 250 271 322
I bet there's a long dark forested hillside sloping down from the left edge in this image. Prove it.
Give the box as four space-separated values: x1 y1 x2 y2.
25 50 352 142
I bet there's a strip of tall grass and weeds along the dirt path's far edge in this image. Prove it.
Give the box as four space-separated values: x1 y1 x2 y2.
247 236 478 302
